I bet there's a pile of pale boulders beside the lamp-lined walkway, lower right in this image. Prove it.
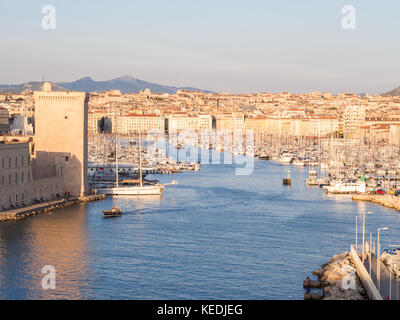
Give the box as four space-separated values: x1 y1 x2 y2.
303 252 368 300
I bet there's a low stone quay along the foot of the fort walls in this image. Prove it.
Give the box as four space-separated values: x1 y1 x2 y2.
0 194 106 222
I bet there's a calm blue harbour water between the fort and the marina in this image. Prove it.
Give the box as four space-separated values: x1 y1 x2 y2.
0 161 400 299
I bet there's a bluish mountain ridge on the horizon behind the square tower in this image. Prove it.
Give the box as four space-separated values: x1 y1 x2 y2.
0 76 213 93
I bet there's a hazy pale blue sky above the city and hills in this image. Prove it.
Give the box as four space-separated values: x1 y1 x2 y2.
0 0 400 93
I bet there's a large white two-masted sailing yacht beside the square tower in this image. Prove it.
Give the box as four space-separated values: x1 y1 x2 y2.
97 133 165 196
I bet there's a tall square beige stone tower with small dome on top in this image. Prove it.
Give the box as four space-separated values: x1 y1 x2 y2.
34 82 89 196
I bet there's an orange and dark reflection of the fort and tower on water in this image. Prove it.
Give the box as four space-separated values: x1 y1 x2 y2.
0 205 91 299
